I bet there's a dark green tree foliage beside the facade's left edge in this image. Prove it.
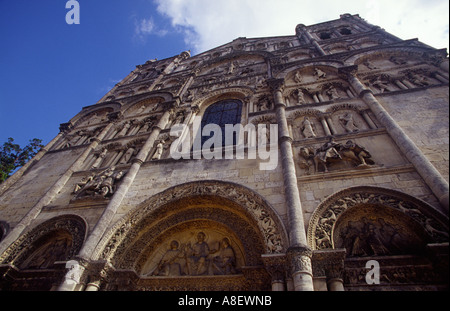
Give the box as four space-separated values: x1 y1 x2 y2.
0 137 44 183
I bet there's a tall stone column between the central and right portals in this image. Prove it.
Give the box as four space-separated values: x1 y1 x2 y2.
268 79 313 291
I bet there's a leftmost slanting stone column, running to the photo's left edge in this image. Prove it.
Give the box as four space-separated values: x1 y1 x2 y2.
0 122 113 254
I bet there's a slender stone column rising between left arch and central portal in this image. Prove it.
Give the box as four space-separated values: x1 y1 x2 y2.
73 104 172 260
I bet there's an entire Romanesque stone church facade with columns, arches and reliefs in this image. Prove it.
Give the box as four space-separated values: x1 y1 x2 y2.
0 14 449 291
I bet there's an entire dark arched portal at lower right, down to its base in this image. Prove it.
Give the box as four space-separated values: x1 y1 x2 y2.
308 186 448 290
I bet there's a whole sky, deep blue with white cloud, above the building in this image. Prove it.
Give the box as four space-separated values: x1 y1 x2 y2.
0 0 449 149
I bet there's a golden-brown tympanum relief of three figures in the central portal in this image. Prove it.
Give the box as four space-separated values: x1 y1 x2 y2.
142 229 243 277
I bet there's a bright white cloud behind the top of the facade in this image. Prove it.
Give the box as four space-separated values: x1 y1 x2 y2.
154 0 449 54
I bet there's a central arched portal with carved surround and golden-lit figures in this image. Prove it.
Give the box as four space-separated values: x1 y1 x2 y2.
96 181 287 290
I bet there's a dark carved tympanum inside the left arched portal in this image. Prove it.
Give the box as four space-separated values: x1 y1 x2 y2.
21 237 72 269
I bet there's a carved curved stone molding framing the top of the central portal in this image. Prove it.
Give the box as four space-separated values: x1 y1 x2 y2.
94 181 287 268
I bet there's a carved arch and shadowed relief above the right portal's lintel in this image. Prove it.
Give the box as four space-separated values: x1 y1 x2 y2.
308 186 448 256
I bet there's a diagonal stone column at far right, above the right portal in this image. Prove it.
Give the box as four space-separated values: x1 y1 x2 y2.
341 66 449 215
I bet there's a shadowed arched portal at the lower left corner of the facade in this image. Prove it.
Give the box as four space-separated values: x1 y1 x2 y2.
0 215 87 290
